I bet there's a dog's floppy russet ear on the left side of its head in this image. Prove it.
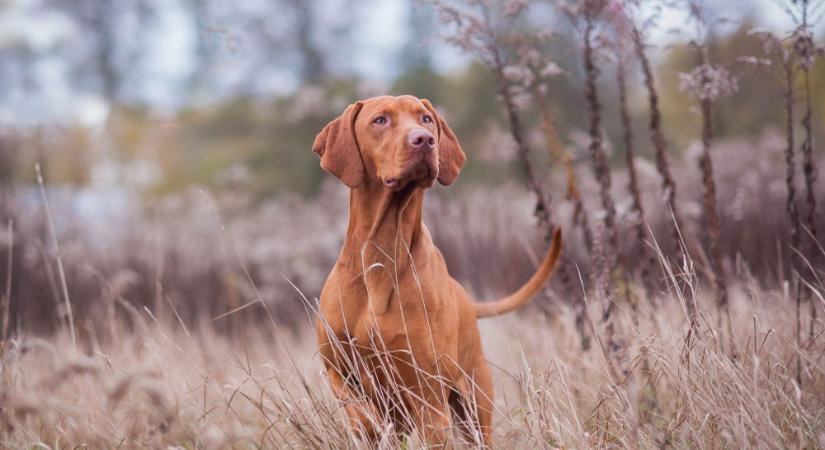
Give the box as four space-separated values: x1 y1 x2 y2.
312 102 364 188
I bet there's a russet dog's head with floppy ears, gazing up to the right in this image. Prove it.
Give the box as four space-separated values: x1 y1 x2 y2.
312 95 466 191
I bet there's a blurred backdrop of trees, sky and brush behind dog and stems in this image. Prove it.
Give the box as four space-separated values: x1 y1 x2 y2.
0 0 825 336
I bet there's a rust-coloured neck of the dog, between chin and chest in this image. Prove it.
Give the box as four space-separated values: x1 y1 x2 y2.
341 182 424 273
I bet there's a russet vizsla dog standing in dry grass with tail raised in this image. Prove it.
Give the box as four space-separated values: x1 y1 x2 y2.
312 96 562 446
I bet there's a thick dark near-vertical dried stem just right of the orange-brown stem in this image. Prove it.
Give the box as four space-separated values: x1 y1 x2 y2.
583 14 619 292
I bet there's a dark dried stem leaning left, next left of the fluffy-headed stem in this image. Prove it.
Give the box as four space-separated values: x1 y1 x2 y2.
632 26 685 257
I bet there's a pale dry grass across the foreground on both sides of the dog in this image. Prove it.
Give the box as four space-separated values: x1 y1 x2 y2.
0 268 825 448
